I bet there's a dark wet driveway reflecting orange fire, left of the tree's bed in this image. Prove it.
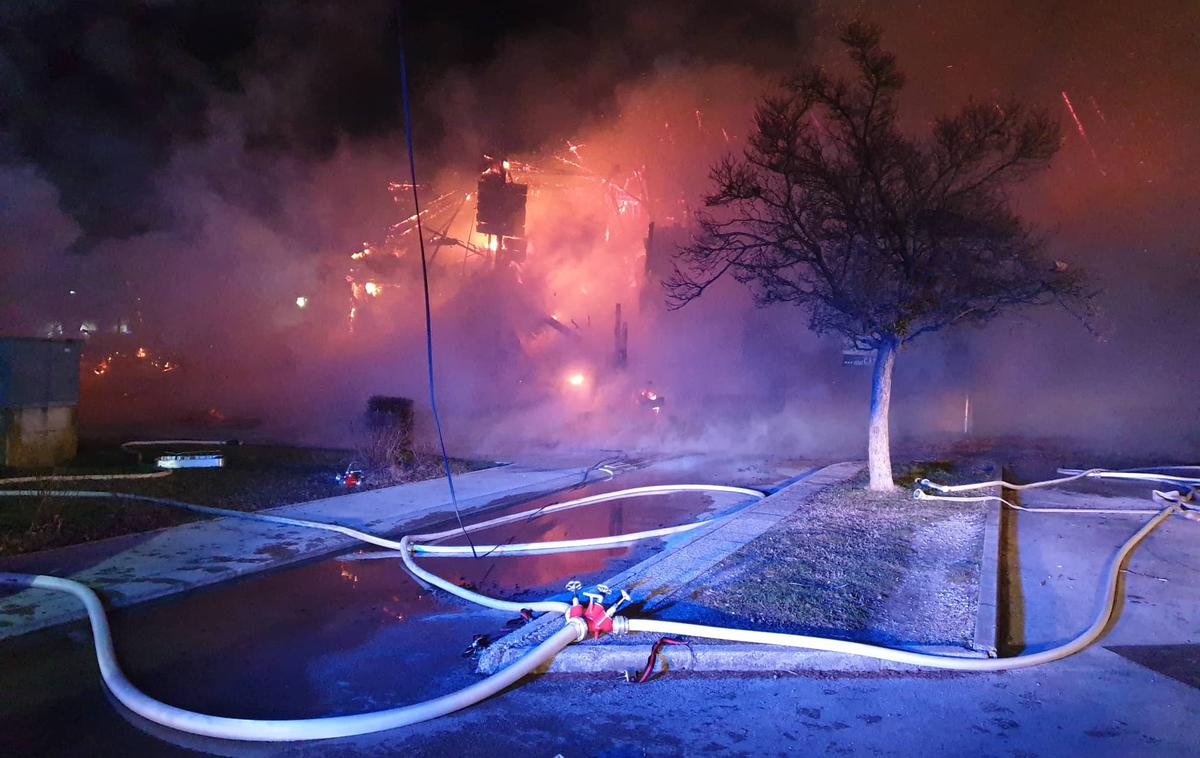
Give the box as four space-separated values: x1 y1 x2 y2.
0 462 766 754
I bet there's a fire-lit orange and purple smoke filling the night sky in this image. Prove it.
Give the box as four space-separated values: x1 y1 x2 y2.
0 0 1200 462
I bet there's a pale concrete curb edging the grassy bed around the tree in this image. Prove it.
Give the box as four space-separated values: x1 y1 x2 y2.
476 463 998 674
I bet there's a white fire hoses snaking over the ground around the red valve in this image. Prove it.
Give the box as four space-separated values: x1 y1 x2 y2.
0 469 1200 741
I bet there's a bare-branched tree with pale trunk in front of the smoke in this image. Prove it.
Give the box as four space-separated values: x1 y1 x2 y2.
665 23 1086 489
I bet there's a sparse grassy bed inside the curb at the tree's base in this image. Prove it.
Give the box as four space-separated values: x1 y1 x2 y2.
697 462 995 646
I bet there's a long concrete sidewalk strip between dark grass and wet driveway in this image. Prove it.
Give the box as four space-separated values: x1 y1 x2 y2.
0 465 586 639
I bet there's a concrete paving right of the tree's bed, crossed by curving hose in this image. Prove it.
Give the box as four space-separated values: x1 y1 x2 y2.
1001 482 1200 666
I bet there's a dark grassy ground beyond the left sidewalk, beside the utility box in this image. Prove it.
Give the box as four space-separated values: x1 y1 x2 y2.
0 445 491 555
